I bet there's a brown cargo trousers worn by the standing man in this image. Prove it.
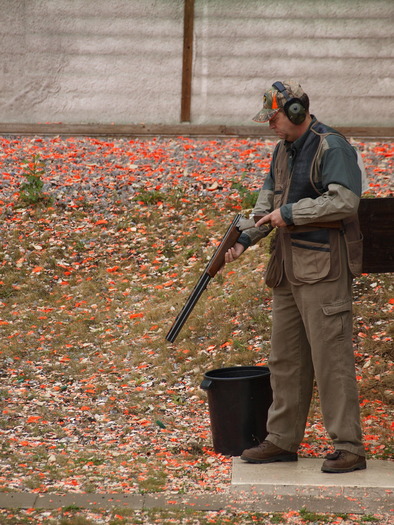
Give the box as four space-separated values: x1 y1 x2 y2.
266 246 365 456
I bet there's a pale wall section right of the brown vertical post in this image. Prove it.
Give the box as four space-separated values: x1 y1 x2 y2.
192 0 394 126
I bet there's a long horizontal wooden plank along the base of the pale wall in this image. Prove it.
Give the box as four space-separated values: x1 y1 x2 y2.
0 122 394 140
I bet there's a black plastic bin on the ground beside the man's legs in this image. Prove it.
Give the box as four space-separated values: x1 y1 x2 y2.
201 366 272 456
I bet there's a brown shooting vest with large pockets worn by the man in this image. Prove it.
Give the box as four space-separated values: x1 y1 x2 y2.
265 122 362 287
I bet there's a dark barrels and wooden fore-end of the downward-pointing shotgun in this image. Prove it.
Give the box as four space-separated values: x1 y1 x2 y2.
166 214 242 343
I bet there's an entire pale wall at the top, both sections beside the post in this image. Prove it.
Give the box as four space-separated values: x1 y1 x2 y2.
0 0 394 126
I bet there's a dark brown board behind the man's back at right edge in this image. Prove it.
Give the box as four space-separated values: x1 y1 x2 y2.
358 197 394 273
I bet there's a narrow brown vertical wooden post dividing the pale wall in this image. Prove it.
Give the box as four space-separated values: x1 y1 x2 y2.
181 0 194 122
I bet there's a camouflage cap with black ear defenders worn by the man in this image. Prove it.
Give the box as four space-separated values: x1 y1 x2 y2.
253 80 309 125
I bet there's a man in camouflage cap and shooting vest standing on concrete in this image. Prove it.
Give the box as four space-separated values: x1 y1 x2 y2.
226 81 366 472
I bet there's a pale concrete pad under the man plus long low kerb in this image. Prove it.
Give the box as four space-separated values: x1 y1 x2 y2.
0 458 394 512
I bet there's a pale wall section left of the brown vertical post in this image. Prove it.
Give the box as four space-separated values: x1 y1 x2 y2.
0 0 183 124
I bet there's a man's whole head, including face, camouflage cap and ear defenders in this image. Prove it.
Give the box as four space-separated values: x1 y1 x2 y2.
253 81 311 142
